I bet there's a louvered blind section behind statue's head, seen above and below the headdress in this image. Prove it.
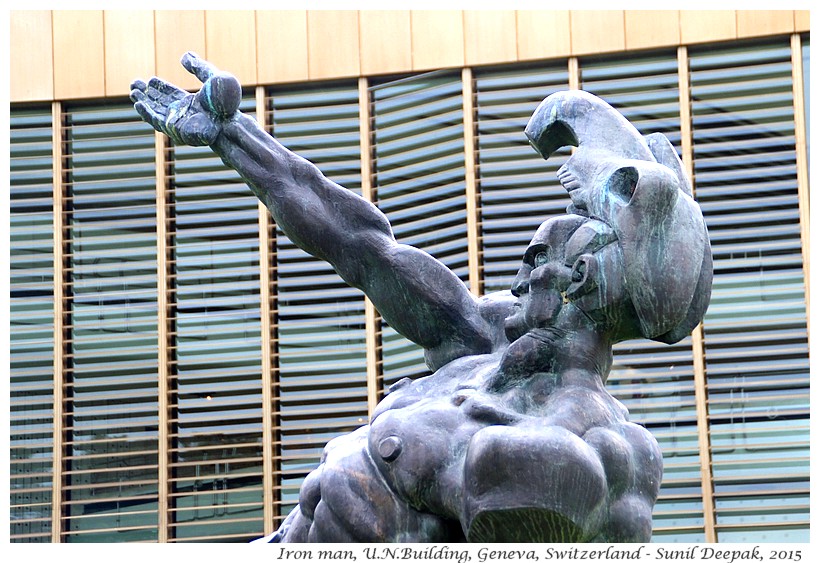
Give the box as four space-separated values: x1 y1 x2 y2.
579 51 704 542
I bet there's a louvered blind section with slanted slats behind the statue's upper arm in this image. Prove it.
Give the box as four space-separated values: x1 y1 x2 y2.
370 72 468 388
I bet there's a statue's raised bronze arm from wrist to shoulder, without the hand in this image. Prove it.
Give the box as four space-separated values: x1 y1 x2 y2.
205 114 491 369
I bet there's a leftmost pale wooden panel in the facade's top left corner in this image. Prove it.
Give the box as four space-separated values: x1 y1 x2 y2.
9 10 54 102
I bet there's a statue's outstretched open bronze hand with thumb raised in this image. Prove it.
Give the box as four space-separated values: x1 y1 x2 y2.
131 52 242 146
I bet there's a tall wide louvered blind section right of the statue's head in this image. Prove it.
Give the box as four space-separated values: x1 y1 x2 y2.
690 39 809 542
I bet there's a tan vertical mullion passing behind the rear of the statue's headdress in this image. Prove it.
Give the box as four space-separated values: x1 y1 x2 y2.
678 41 717 543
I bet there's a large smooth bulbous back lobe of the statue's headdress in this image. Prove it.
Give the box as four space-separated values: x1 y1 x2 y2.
610 163 712 342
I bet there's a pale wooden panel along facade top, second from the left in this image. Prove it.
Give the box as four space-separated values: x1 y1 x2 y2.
52 10 105 100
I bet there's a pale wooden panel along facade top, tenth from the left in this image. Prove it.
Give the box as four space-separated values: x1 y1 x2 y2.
464 10 517 65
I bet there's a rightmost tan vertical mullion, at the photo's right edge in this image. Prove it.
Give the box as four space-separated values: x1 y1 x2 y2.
791 33 811 336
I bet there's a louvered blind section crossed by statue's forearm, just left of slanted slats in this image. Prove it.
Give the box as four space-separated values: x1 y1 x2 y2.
267 83 367 517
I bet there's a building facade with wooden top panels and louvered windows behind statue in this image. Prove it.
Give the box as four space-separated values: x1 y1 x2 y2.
9 10 810 542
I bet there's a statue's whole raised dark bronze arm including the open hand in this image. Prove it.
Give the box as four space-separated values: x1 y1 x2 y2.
131 53 493 370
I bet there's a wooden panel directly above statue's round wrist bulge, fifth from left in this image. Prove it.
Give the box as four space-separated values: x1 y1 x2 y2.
205 10 256 84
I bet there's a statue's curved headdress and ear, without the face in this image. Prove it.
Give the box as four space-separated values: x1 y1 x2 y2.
525 91 712 343
